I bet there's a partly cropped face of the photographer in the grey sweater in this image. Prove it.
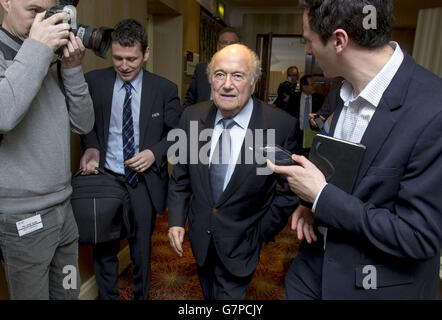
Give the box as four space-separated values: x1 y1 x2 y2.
0 0 56 40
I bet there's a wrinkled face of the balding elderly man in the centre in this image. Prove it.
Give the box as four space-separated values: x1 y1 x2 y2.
210 46 255 118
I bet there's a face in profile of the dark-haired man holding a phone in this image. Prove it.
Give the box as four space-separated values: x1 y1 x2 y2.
303 10 337 77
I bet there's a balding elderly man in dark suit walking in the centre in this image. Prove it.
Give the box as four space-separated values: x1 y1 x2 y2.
168 44 298 299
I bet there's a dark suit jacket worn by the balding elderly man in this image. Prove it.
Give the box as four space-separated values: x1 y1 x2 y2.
168 100 298 276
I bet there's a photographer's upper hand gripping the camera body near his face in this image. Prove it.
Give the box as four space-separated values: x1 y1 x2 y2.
29 11 70 52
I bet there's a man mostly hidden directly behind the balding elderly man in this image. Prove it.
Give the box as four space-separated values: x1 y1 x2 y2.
183 27 240 108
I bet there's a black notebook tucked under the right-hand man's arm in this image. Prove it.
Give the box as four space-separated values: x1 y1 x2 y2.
309 134 365 193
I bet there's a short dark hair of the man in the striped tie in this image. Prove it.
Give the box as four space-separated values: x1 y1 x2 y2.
112 19 148 52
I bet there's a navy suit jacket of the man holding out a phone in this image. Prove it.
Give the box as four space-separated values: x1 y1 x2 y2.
301 54 442 299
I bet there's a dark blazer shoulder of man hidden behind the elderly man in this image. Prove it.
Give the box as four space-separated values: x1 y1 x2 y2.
183 63 211 108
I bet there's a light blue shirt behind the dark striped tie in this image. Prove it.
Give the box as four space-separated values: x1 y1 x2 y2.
104 70 143 174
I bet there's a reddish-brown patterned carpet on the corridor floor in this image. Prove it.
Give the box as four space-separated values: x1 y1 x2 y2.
119 213 299 300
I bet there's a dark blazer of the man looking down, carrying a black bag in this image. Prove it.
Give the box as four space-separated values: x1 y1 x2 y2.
82 68 182 213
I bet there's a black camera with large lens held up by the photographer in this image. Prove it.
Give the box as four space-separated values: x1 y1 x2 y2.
45 0 114 59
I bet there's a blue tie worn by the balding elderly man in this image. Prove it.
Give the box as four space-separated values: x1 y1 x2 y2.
209 118 235 203
